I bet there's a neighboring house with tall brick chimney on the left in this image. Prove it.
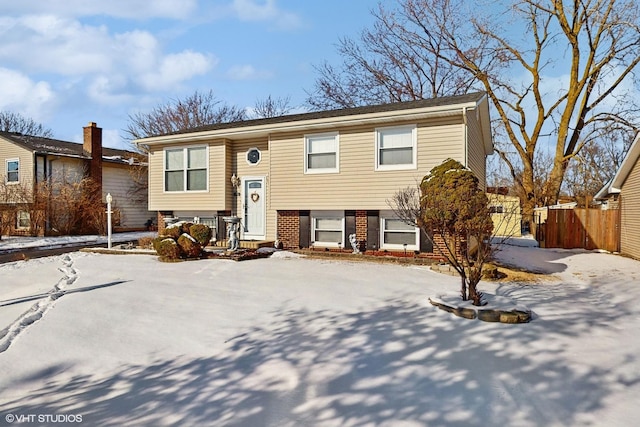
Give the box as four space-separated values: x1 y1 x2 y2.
0 122 155 234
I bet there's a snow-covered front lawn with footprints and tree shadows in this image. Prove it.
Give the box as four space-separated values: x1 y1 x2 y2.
0 241 640 427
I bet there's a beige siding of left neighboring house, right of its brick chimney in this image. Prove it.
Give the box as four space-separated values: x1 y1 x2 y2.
102 163 156 227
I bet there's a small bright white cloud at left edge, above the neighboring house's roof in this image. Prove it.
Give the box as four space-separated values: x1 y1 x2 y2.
0 67 55 121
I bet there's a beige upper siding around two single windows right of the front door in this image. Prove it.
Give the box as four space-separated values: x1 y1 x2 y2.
269 117 464 210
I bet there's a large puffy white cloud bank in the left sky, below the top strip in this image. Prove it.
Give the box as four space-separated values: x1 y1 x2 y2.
0 15 216 100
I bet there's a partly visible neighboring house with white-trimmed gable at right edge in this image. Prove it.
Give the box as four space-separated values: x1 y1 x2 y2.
594 133 640 259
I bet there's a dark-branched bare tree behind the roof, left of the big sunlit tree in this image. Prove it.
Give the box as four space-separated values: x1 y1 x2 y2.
307 0 475 110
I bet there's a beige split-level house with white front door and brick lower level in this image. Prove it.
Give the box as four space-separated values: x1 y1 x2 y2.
136 93 493 252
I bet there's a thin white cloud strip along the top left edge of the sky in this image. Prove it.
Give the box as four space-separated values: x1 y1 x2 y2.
0 0 198 20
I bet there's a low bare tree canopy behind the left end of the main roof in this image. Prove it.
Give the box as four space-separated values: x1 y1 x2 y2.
124 91 246 140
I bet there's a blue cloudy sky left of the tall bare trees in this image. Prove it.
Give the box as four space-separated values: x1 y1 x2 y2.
0 0 376 148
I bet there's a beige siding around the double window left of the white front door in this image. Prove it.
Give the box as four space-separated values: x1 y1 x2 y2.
149 140 231 211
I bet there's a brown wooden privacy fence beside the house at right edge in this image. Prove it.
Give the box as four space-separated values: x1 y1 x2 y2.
539 209 620 252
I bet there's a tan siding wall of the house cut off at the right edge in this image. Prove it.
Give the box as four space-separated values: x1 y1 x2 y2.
620 160 640 259
